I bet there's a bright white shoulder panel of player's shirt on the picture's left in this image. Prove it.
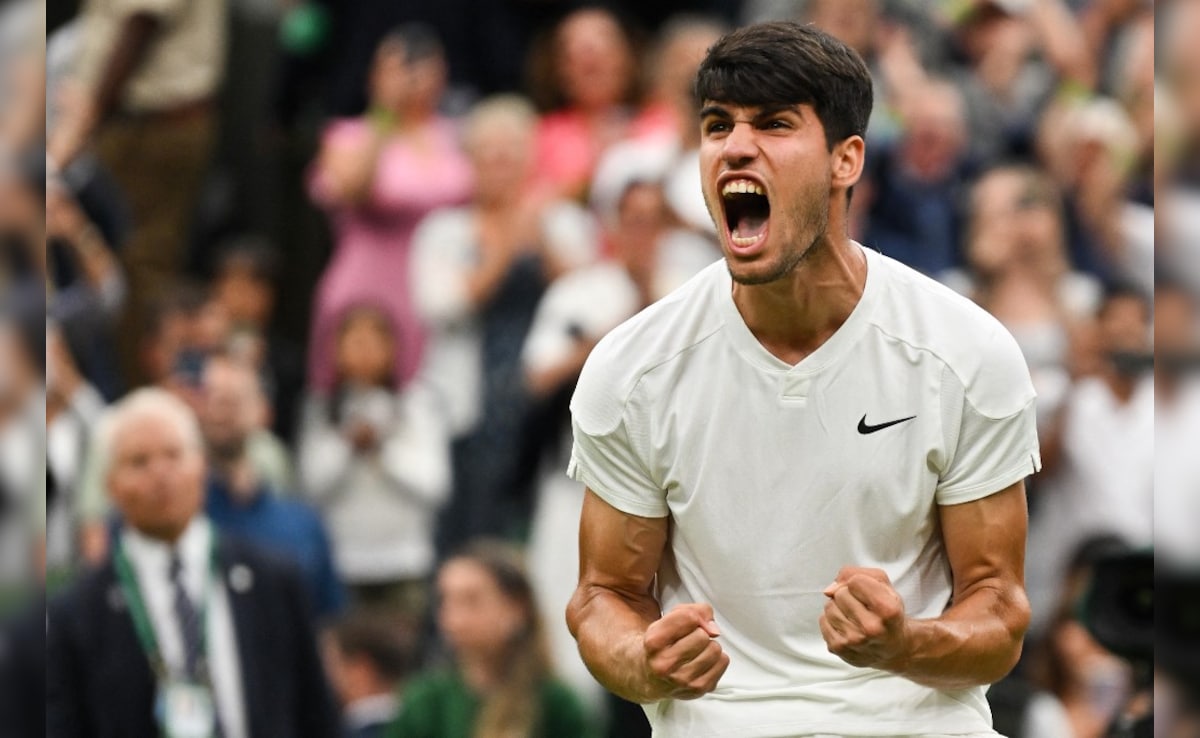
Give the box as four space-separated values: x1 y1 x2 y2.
571 262 725 431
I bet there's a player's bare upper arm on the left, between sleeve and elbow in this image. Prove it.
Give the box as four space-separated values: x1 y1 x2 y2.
580 490 670 596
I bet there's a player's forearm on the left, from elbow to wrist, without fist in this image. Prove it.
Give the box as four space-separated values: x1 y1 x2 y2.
566 584 667 703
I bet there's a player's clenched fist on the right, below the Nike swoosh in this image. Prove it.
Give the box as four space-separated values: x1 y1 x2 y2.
821 566 907 668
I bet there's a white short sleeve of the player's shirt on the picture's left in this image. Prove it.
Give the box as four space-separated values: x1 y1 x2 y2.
566 340 670 517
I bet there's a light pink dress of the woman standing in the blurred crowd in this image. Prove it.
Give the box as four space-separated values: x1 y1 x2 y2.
308 119 473 390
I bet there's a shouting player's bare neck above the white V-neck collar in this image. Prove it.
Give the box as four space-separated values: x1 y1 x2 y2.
733 236 866 364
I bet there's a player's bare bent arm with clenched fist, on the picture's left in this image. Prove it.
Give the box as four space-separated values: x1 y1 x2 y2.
566 490 728 703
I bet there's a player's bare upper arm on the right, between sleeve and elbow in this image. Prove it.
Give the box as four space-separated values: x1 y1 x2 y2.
938 481 1028 604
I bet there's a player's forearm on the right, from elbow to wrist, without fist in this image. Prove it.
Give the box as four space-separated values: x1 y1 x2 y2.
884 584 1030 690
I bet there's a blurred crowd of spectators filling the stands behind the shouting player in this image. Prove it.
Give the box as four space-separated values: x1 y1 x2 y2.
0 0 1200 738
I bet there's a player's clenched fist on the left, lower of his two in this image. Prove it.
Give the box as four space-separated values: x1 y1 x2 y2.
642 604 730 700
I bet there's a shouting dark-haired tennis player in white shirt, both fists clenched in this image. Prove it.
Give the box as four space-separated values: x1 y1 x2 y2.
568 23 1040 738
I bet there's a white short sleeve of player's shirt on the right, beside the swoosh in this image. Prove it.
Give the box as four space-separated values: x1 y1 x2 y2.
936 323 1042 505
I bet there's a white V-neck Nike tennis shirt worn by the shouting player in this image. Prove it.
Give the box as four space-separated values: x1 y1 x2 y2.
568 250 1040 738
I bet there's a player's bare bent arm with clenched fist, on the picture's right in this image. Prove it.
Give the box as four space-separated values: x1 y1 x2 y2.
821 481 1030 690
